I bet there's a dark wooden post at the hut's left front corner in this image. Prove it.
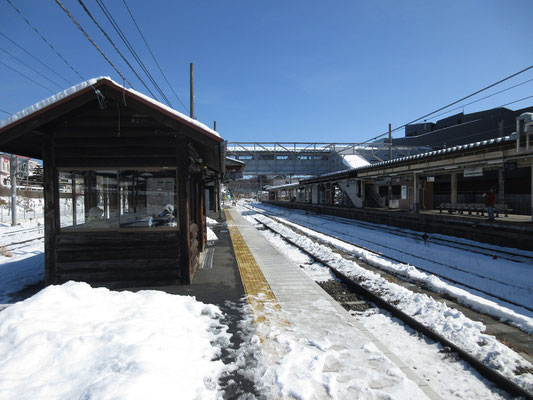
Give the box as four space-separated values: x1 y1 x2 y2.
43 136 59 285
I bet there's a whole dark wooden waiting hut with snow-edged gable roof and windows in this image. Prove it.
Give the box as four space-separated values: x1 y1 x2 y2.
0 78 224 287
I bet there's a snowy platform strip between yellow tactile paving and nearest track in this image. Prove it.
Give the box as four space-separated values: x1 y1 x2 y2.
224 210 440 399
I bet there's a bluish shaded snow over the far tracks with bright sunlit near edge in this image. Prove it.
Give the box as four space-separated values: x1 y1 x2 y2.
248 204 533 333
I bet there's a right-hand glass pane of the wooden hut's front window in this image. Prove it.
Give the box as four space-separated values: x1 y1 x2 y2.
120 169 177 228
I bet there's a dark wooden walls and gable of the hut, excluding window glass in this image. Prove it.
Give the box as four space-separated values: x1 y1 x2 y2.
0 79 222 288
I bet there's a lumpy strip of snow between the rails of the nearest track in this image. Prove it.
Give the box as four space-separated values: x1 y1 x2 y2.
246 211 533 391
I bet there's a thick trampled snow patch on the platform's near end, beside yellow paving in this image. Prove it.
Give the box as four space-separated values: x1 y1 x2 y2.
250 298 426 400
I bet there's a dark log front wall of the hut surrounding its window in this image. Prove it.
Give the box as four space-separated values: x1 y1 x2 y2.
47 100 193 288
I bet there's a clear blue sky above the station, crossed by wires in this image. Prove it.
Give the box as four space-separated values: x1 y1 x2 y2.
0 0 533 142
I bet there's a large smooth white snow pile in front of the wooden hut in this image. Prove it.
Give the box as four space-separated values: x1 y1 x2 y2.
0 282 230 399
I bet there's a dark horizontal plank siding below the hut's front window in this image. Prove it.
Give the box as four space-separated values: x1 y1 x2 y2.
55 231 182 288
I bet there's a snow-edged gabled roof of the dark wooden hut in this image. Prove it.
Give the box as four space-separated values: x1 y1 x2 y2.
0 77 223 164
